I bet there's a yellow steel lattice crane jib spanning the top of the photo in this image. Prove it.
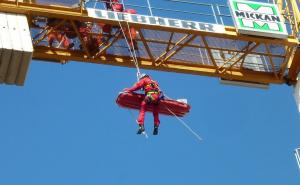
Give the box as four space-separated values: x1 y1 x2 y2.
0 0 300 84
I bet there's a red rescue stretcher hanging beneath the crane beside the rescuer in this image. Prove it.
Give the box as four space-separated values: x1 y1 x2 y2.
116 92 191 117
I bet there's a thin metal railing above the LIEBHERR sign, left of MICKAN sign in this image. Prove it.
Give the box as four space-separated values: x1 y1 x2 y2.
86 0 229 24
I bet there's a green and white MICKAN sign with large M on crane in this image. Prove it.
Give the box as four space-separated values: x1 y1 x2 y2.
229 0 288 38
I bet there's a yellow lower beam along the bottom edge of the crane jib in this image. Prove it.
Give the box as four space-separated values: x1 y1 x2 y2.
33 46 282 84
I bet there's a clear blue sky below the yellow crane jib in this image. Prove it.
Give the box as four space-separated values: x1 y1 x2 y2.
0 0 300 185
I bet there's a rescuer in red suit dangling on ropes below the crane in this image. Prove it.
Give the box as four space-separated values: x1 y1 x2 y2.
123 74 161 135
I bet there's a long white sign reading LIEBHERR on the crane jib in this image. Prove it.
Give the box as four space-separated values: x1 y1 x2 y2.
87 8 225 33
